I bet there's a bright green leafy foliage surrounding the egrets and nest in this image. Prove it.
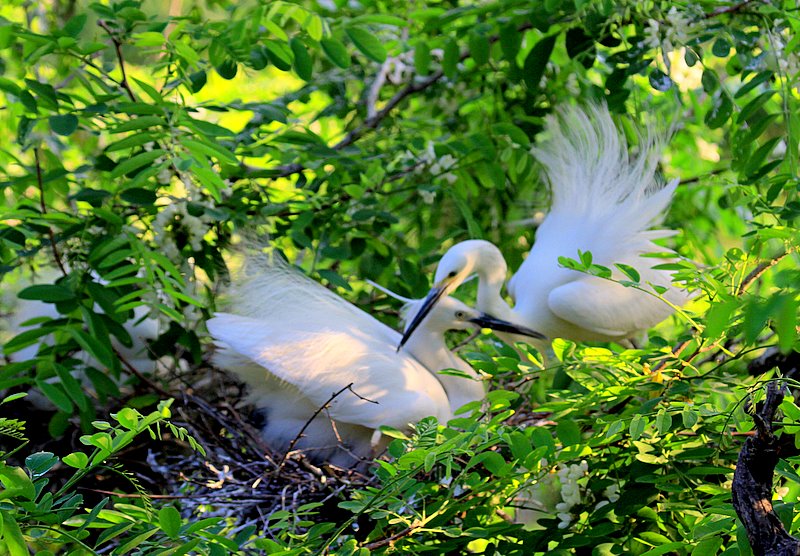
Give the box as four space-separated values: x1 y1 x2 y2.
0 0 800 555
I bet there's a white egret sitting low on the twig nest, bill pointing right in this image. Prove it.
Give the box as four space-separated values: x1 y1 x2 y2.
207 263 538 466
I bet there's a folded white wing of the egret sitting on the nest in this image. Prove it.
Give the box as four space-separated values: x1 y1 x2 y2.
207 313 449 428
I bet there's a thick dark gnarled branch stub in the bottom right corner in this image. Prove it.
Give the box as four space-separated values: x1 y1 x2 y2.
731 382 800 556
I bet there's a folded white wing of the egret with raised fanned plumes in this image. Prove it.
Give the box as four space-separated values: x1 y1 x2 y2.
547 276 673 338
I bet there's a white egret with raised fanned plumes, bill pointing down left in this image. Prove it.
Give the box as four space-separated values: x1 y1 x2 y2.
400 104 689 346
